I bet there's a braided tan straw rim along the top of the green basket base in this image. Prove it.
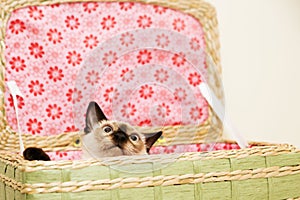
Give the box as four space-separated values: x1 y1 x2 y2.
0 140 300 172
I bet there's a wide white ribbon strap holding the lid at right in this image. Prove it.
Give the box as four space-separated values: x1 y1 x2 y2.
199 82 249 148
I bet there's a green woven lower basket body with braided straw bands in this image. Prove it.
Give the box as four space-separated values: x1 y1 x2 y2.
0 145 300 199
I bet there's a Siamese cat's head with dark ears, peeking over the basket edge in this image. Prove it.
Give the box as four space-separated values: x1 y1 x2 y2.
82 102 162 158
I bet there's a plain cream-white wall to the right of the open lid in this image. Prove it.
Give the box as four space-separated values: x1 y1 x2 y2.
207 0 300 147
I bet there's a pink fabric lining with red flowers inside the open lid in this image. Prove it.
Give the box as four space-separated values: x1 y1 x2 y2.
5 2 208 160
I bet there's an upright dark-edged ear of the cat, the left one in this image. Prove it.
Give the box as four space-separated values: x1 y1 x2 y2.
84 101 107 133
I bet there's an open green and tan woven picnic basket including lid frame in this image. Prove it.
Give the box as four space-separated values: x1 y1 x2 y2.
0 0 300 200
